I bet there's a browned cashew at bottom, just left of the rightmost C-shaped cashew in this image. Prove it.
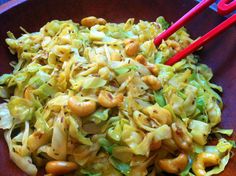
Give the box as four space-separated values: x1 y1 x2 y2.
159 153 188 174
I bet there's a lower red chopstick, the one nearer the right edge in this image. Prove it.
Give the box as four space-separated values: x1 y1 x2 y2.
165 14 236 65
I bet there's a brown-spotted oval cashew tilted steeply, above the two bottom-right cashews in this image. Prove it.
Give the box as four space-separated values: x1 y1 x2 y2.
171 122 193 152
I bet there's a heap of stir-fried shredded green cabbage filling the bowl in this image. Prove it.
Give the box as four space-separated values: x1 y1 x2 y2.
0 17 233 176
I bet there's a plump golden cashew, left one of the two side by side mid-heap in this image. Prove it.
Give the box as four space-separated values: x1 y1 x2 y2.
68 96 96 117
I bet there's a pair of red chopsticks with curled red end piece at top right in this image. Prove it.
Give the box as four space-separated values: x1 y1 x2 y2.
154 0 236 65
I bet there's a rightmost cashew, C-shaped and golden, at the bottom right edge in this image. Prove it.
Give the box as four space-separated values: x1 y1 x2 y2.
192 152 220 176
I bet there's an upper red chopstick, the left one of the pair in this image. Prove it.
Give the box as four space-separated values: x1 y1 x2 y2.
154 0 215 46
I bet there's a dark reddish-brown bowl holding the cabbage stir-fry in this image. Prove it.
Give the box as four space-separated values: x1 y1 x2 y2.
0 0 236 176
